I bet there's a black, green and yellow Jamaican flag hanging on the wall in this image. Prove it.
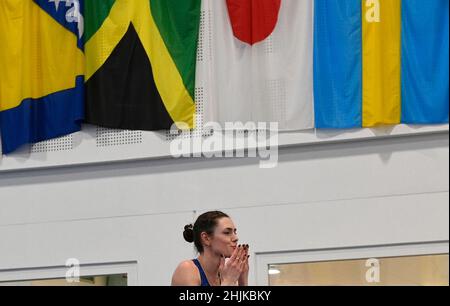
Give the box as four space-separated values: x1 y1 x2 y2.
85 0 201 130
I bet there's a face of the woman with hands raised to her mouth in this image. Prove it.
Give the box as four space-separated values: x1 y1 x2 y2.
210 218 239 257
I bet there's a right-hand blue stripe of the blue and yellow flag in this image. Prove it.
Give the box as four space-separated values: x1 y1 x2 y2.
402 0 449 124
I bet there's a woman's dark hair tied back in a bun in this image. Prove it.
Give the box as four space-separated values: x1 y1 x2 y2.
183 211 229 253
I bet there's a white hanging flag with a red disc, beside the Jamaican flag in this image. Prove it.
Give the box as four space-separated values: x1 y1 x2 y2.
204 0 314 130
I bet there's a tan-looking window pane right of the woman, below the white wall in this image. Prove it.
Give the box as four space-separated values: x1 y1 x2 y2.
269 254 449 286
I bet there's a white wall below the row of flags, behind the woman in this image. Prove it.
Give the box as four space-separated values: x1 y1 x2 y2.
0 132 449 285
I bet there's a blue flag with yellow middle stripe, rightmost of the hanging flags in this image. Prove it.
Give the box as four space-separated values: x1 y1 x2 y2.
314 0 449 128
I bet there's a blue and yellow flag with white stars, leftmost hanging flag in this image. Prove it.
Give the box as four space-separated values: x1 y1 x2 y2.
0 0 84 154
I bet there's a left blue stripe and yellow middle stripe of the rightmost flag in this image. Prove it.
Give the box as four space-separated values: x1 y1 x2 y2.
314 0 401 128
